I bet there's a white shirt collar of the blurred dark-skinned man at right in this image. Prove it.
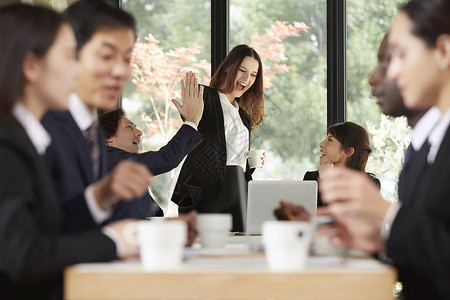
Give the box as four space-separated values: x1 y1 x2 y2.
411 106 441 151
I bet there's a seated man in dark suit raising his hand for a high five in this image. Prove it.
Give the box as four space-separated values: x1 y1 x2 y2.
99 73 203 222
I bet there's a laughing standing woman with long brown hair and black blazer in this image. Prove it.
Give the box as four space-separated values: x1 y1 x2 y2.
172 45 264 231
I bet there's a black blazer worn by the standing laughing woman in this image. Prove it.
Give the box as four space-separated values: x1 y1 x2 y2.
172 86 254 212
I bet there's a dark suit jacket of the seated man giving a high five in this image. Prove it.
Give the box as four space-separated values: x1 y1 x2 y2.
106 125 203 222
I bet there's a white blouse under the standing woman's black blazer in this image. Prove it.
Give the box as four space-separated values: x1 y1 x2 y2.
218 92 250 172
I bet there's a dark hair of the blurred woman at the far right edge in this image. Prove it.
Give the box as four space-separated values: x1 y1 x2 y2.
400 0 450 48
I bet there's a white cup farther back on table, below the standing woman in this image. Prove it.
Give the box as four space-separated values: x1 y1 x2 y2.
195 213 233 248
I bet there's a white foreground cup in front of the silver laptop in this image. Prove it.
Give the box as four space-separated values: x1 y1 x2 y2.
262 221 312 271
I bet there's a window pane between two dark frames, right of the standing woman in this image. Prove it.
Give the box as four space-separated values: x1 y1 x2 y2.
230 0 327 180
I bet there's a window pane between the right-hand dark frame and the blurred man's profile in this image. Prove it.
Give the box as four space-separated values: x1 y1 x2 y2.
347 0 409 200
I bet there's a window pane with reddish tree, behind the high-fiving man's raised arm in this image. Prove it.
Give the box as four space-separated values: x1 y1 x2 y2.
122 0 211 213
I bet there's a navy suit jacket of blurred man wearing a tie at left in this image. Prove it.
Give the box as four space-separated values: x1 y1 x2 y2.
42 112 107 232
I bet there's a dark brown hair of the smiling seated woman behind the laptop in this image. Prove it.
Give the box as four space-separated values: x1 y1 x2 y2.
328 122 372 172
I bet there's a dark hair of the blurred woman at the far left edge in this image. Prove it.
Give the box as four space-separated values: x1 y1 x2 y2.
0 4 65 117
